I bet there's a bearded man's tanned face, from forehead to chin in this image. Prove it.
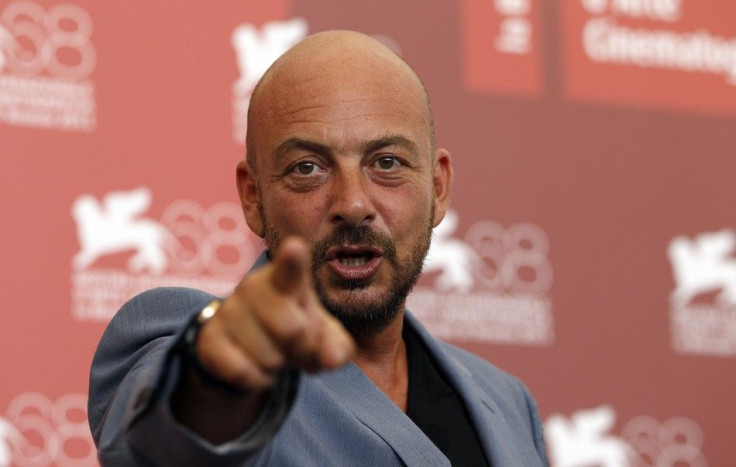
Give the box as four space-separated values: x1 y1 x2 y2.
239 53 449 330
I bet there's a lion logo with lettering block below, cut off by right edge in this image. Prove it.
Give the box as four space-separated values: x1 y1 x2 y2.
667 229 736 356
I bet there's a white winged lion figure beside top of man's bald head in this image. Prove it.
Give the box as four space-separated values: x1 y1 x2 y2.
232 18 307 94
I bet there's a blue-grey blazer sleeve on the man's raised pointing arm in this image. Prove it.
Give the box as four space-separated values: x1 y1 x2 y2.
88 288 299 465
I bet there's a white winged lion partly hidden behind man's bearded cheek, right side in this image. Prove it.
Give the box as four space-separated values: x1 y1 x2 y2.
424 211 480 293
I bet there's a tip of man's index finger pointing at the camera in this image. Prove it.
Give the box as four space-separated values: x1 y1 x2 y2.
271 237 310 294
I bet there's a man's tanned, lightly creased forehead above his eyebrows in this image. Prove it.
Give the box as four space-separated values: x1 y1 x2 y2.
249 53 430 157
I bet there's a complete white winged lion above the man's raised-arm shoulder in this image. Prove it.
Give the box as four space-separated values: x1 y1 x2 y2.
72 187 172 274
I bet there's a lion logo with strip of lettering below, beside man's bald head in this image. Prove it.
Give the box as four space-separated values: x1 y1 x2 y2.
232 18 307 144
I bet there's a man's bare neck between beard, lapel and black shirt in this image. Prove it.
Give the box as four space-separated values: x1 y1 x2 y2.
354 312 409 410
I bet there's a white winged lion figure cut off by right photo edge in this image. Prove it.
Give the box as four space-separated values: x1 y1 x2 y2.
667 229 736 306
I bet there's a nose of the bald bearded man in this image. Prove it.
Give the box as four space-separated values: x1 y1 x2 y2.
329 167 376 227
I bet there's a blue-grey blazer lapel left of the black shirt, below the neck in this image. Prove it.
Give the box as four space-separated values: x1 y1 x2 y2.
319 363 450 466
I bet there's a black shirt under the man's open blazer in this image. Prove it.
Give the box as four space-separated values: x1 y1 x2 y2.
403 326 490 467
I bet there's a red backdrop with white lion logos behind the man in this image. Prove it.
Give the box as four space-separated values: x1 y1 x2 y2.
0 0 736 467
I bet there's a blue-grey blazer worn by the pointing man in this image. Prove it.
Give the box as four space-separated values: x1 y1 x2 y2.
89 288 547 467
